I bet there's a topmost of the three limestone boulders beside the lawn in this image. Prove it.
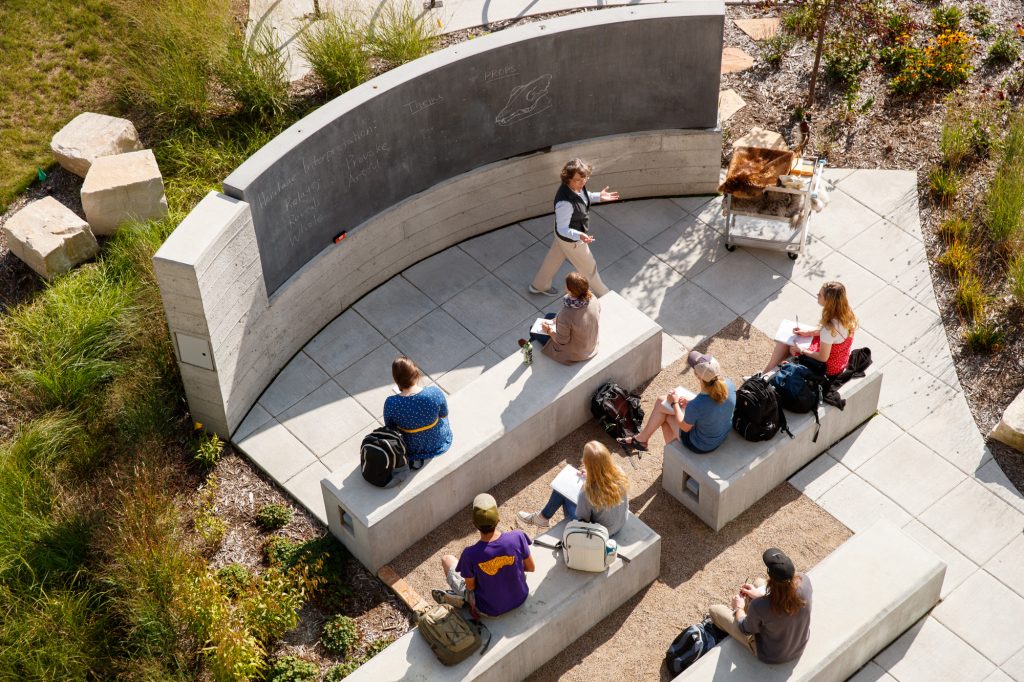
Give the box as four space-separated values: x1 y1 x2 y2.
50 112 142 177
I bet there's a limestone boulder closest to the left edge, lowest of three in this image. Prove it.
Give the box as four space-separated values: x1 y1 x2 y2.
3 197 99 280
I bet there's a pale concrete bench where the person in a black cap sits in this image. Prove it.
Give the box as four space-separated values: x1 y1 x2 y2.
675 521 946 682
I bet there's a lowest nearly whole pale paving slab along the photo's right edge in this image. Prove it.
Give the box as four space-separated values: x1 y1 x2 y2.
932 570 1024 665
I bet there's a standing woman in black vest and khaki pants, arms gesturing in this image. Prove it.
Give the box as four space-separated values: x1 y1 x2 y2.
529 159 618 296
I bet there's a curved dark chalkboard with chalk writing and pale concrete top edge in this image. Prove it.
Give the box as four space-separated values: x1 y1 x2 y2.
224 2 723 294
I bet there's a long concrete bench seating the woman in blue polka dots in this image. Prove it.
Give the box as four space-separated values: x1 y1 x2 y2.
321 292 662 572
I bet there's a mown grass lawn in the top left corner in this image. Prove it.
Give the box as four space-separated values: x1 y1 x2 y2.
0 0 119 211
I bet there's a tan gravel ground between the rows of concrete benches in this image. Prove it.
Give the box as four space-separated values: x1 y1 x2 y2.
391 319 852 682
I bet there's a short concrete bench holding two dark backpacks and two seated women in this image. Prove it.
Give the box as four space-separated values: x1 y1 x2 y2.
662 371 882 530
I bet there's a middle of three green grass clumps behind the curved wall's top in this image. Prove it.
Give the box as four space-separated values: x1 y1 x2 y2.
299 15 371 96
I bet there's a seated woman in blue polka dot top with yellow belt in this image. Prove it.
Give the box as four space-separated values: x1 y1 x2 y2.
384 355 452 469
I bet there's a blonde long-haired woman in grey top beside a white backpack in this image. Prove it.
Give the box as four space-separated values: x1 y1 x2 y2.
517 440 630 536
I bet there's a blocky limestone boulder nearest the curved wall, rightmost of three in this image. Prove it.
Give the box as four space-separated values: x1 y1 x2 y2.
82 150 167 235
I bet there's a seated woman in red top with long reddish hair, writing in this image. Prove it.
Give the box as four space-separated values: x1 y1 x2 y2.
764 282 857 377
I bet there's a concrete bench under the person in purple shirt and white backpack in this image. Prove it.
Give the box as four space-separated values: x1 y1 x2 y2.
346 514 662 682
